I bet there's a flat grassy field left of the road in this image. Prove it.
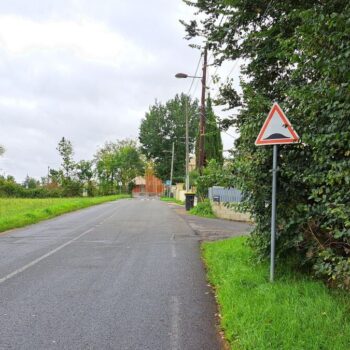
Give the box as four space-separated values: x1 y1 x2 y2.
0 195 130 232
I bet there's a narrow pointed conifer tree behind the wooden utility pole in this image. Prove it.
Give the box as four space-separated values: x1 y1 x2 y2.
196 95 224 166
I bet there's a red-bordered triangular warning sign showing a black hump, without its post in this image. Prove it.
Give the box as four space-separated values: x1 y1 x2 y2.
255 103 300 146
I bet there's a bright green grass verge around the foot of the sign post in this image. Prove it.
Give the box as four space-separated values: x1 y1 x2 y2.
202 237 350 350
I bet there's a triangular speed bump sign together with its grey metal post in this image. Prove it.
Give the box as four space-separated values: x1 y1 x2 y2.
255 103 300 282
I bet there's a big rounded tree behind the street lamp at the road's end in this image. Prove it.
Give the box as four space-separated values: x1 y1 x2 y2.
139 94 199 181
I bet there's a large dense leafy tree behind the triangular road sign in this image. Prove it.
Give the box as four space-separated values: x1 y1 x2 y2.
185 0 350 289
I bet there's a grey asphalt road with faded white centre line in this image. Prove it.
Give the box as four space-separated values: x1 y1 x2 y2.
0 200 220 350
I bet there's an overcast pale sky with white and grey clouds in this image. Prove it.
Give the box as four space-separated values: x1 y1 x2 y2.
0 0 239 181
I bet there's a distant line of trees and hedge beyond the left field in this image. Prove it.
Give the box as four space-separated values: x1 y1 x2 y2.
0 137 145 198
